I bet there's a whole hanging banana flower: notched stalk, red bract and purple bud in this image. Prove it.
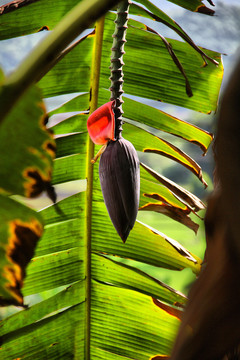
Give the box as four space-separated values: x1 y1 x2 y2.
87 1 140 242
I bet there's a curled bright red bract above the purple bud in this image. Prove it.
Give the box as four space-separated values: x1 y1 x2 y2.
87 101 115 145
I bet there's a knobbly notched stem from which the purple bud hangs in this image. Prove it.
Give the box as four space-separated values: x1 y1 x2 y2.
110 0 130 139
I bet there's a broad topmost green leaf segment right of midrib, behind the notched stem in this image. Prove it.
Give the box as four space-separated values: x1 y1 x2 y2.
100 14 223 113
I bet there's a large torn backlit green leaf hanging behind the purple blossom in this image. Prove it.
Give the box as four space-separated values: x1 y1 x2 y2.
0 0 222 360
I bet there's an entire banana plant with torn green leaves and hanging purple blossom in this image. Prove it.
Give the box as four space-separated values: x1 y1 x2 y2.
0 0 223 360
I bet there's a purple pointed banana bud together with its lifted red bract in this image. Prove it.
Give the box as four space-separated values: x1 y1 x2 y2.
88 102 140 242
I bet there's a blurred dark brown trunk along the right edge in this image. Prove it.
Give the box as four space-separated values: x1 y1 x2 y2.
171 62 240 360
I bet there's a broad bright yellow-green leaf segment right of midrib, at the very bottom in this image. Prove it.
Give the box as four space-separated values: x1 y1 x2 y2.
91 282 179 360
